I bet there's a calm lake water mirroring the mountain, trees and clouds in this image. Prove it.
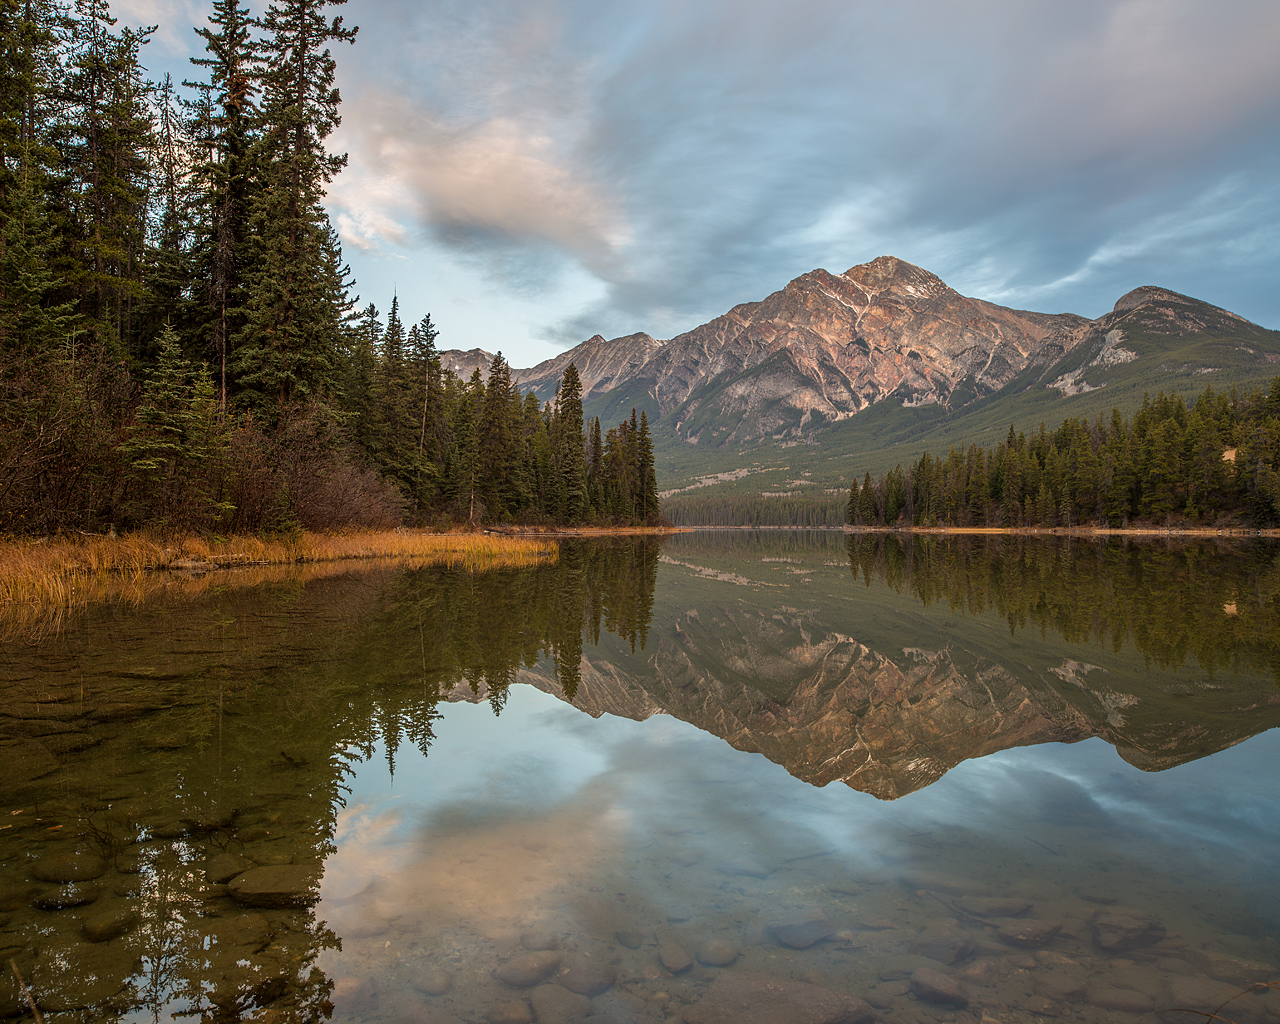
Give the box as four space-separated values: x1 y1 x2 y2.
0 531 1280 1024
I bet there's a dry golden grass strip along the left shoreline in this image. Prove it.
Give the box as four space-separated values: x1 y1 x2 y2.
0 530 559 639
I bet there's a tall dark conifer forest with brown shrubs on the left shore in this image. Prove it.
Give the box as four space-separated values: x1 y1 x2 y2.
0 0 660 534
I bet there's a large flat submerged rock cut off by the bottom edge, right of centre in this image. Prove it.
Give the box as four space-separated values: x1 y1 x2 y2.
685 970 876 1024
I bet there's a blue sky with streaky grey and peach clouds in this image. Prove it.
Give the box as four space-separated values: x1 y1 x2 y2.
129 0 1280 367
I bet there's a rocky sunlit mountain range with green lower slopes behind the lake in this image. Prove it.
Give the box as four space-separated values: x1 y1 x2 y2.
442 256 1280 493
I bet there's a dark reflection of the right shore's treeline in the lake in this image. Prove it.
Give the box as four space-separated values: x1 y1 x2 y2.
847 534 1280 681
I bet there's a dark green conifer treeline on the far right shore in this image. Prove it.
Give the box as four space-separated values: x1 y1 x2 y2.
845 378 1280 529
